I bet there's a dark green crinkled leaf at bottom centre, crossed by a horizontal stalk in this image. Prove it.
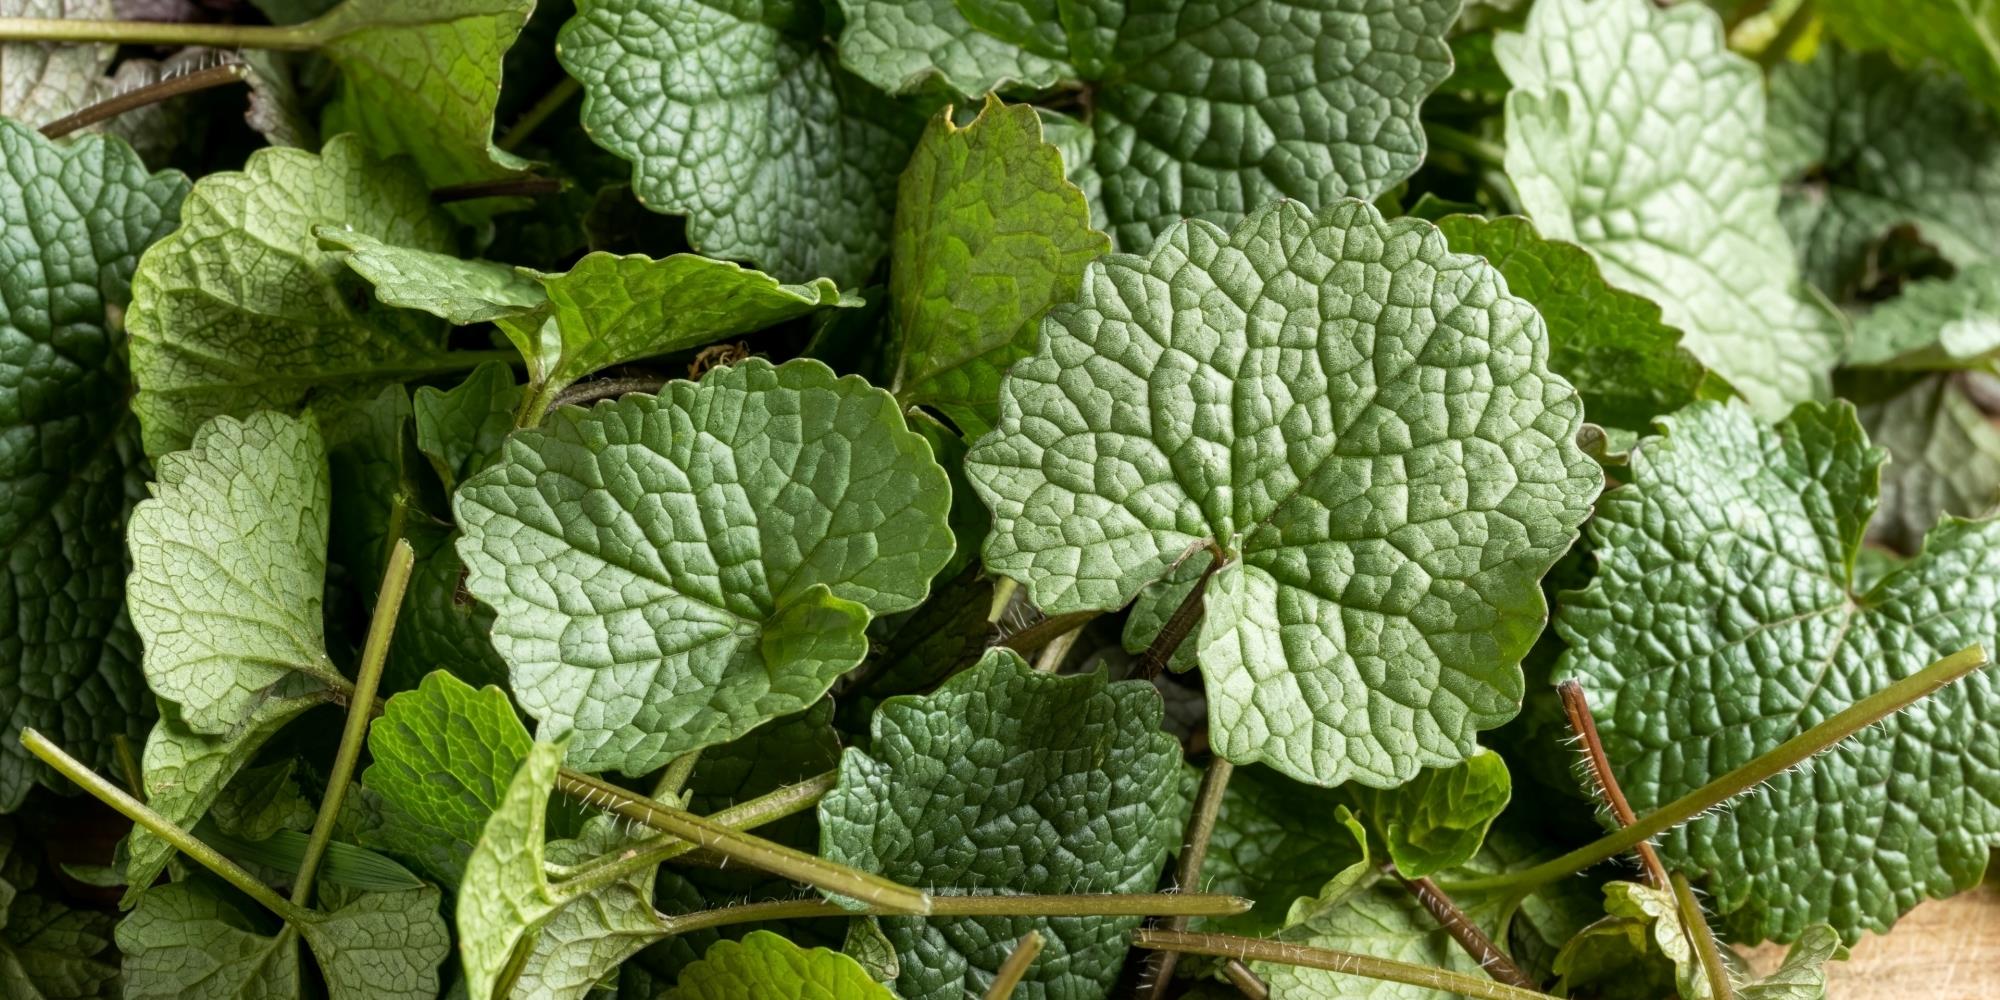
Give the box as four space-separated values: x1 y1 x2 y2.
820 650 1186 1000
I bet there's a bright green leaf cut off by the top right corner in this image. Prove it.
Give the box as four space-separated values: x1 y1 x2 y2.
1818 0 2000 114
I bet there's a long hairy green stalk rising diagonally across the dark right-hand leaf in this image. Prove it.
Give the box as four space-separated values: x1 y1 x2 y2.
1450 646 1986 892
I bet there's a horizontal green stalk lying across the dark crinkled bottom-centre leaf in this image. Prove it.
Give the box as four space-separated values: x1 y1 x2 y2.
658 892 1250 934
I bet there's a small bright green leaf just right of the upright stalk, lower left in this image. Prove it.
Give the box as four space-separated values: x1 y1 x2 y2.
362 670 534 888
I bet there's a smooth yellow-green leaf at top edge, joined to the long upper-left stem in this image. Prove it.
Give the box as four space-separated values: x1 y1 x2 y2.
312 0 534 199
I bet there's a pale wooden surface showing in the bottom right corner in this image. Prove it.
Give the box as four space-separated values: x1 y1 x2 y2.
1748 878 2000 1000
